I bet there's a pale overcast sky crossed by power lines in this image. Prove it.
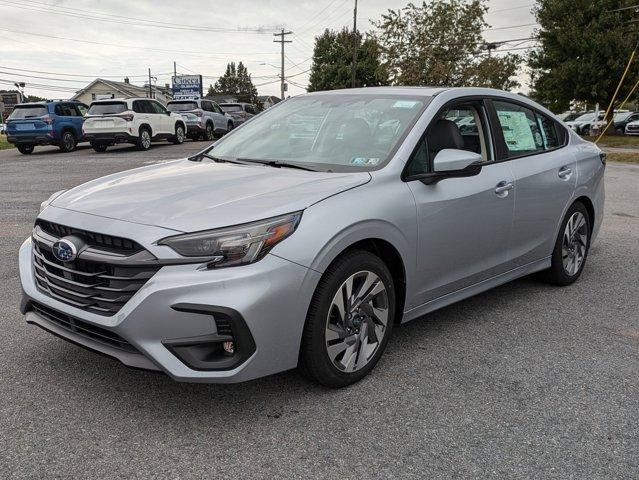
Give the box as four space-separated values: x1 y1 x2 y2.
0 0 535 98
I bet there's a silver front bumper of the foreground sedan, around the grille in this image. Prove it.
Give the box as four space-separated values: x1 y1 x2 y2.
20 207 320 383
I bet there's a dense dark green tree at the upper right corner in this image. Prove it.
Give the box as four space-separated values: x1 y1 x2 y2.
529 0 639 112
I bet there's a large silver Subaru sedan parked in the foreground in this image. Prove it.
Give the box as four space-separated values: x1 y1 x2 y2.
20 87 605 387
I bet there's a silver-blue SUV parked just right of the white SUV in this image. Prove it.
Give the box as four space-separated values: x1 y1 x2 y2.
166 98 233 140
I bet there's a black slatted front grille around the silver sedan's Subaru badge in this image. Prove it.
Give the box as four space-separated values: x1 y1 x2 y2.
33 222 160 315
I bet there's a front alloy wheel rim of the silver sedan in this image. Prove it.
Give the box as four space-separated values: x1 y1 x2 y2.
325 271 389 373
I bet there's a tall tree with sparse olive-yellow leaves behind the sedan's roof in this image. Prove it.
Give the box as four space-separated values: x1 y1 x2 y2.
374 0 520 90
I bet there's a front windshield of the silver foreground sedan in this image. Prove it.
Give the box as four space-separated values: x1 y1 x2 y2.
208 94 430 171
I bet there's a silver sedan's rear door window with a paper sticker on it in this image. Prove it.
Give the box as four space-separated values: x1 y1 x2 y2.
493 101 545 158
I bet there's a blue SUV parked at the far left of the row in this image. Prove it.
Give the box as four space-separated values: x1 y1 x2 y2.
6 100 89 155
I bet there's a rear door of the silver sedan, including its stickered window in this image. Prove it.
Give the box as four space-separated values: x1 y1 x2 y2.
491 100 577 267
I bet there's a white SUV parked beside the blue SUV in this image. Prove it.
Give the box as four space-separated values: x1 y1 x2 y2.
82 98 186 152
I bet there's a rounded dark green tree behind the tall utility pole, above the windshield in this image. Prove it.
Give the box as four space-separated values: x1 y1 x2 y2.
308 28 388 92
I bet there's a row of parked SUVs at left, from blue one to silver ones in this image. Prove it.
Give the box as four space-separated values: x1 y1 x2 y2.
5 98 256 154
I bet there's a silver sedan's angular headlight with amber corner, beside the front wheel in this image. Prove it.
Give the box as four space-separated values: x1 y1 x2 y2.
158 212 302 267
